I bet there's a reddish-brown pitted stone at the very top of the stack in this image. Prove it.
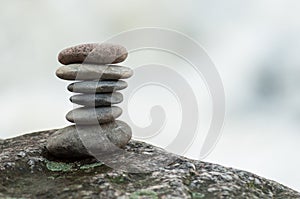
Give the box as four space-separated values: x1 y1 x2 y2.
58 43 128 65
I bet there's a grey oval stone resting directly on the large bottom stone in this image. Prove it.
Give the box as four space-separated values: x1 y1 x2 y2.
66 106 122 125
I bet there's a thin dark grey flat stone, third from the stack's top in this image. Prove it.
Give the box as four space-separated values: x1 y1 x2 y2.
68 80 128 93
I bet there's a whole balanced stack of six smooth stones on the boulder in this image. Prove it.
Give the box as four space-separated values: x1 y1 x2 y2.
46 43 133 158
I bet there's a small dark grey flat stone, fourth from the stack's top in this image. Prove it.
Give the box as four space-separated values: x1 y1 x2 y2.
70 92 123 107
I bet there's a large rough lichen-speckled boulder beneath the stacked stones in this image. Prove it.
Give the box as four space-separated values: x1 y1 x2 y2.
0 130 300 199
